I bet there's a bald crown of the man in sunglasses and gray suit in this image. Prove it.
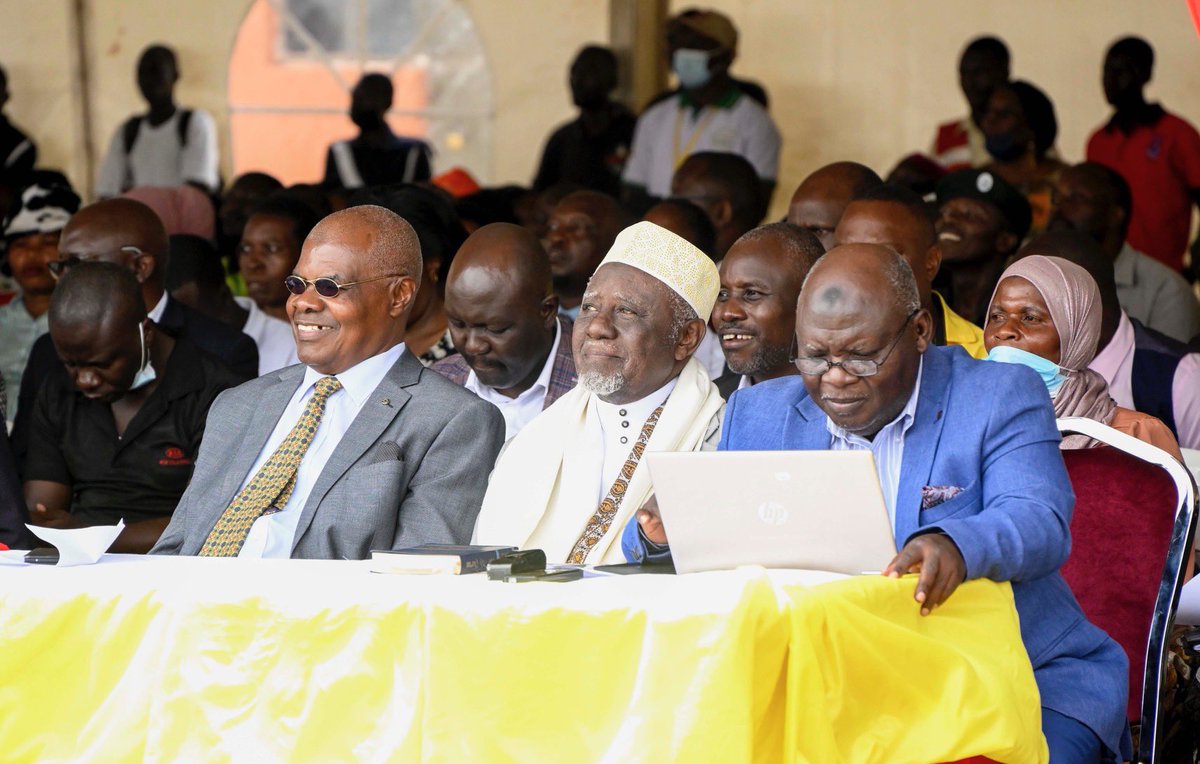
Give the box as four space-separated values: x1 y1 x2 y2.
304 204 421 283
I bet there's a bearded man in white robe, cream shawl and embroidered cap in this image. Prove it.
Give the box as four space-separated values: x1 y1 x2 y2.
473 222 725 564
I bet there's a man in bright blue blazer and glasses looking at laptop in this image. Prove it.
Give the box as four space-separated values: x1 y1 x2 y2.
624 245 1128 764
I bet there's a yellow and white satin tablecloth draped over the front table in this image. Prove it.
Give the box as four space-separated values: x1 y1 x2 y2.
0 555 1045 762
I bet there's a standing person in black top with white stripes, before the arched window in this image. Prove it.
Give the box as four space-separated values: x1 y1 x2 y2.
325 72 432 188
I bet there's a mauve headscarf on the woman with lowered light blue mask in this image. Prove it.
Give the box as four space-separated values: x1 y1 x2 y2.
991 254 1116 449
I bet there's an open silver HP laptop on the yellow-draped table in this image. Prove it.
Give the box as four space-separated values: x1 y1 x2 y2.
646 451 896 574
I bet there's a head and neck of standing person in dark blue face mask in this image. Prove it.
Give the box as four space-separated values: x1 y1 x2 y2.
983 80 1067 235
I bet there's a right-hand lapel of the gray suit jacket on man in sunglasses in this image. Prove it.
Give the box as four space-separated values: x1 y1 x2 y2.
292 350 424 552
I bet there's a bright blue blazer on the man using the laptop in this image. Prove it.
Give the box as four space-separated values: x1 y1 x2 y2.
623 347 1128 751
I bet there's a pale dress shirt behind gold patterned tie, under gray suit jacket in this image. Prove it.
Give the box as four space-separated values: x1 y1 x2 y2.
238 343 404 558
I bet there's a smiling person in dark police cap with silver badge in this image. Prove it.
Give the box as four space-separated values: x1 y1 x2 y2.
934 169 1031 326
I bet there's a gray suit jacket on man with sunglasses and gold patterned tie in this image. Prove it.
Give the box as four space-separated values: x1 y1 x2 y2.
151 351 504 560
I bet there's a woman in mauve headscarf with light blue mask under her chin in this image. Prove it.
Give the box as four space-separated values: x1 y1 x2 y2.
983 254 1183 462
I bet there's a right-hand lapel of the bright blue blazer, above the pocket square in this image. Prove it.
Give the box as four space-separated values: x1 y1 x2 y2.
895 345 950 546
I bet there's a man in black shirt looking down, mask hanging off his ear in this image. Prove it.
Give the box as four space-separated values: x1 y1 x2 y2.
23 263 241 553
